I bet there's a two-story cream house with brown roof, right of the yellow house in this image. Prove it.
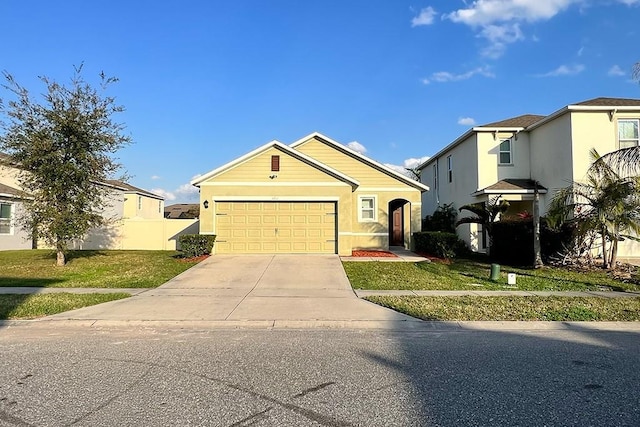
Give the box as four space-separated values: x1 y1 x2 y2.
418 98 640 257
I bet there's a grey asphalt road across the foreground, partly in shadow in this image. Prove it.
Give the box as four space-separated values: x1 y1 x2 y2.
0 327 640 426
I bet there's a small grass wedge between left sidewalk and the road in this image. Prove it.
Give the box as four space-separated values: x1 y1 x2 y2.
0 292 130 320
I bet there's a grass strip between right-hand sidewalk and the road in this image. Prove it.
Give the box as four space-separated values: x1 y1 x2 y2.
365 296 640 321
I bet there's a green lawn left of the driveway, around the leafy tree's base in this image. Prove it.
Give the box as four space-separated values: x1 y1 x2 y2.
0 250 202 288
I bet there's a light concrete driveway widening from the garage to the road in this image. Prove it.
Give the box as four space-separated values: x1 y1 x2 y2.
43 255 421 328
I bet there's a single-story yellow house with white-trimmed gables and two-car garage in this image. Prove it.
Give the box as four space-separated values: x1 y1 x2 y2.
192 133 429 255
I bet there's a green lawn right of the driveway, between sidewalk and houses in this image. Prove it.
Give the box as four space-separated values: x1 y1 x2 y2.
343 259 640 291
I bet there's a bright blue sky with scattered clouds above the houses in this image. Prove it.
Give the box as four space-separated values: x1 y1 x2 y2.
0 0 640 204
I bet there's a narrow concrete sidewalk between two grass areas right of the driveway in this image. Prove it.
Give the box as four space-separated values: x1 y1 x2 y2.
354 289 640 298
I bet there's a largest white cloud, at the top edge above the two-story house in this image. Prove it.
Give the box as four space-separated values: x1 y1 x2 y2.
444 0 580 58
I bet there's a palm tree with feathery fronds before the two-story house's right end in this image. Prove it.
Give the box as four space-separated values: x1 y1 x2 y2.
551 150 640 268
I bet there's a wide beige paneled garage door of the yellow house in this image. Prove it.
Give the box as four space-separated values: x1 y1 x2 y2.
215 202 336 254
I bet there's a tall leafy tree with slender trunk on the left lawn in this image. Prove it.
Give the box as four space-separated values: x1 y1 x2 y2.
0 66 131 266
